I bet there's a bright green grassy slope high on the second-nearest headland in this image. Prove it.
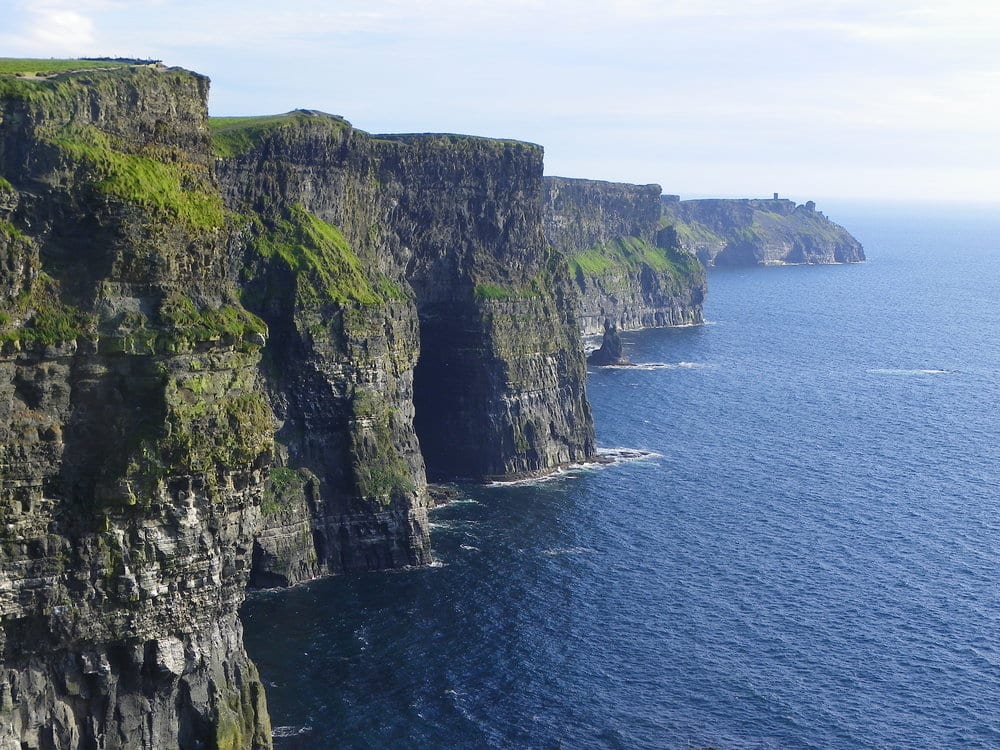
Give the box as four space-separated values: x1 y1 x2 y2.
253 206 406 305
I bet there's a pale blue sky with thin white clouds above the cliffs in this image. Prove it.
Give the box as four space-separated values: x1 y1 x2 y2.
0 0 1000 208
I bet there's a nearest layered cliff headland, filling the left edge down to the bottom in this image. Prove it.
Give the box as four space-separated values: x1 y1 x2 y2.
0 68 272 750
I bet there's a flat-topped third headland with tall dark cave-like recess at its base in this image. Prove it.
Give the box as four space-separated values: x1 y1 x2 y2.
376 136 594 481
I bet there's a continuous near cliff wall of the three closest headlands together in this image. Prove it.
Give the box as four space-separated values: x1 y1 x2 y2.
0 63 594 750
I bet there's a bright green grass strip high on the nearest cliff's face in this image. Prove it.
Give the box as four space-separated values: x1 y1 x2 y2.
51 127 225 230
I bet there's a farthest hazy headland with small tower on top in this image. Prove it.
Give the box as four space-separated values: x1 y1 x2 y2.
660 195 865 266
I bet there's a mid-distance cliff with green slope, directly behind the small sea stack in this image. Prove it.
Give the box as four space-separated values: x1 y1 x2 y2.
545 177 706 334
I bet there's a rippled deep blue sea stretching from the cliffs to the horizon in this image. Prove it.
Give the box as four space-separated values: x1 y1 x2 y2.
245 207 1000 750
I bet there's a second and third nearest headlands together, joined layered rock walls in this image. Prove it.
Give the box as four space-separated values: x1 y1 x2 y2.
215 117 594 585
